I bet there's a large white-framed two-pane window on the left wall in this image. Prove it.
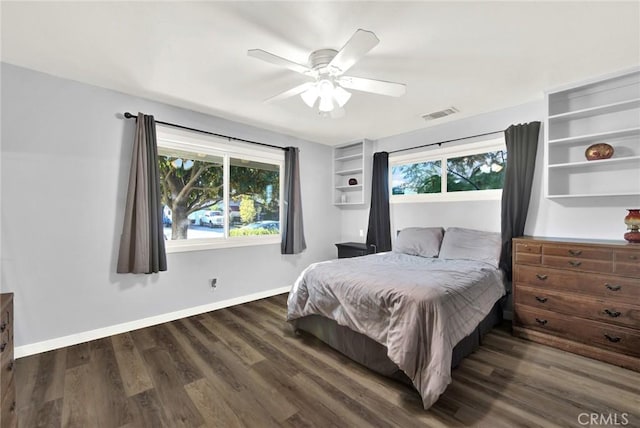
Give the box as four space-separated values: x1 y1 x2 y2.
157 126 284 252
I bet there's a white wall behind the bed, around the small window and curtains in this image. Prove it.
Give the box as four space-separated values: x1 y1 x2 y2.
341 98 637 241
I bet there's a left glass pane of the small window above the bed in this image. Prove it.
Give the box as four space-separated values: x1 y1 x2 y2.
391 160 442 195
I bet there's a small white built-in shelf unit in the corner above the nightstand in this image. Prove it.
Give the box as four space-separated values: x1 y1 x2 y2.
332 140 372 207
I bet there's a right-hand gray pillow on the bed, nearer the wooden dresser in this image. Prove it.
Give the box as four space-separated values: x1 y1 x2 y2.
439 227 502 268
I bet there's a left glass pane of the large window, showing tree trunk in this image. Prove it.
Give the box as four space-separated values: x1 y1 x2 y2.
158 148 224 240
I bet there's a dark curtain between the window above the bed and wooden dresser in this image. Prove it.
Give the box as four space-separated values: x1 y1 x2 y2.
500 122 540 281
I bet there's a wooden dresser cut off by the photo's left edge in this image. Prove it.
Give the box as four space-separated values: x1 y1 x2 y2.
0 293 18 428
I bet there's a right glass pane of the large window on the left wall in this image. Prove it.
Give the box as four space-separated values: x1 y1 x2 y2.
228 158 280 237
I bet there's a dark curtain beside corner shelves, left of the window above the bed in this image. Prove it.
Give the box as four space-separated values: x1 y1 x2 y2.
367 152 391 252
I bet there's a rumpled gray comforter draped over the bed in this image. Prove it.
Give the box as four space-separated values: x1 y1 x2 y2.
287 252 505 409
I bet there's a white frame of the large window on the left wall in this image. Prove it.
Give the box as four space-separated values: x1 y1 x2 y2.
156 124 284 253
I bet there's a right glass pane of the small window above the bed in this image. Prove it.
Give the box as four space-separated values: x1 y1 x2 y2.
447 150 507 192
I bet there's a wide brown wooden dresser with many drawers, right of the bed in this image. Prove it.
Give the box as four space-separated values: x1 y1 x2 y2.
513 237 640 371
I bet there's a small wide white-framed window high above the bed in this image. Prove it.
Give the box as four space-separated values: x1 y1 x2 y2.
389 138 507 202
